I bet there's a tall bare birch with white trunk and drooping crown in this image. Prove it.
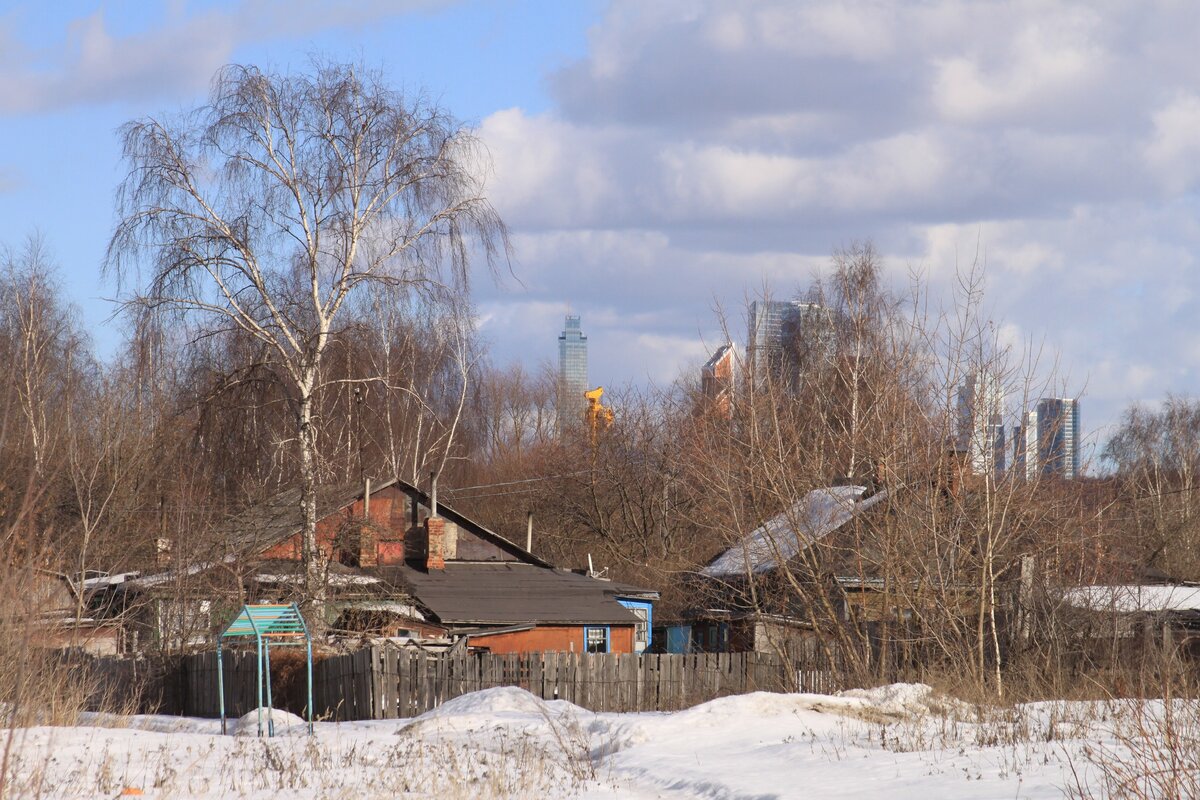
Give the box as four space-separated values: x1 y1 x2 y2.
108 65 508 621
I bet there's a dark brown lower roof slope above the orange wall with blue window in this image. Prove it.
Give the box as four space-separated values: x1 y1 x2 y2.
378 561 637 625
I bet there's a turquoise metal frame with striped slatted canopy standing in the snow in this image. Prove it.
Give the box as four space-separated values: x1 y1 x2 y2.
217 603 312 736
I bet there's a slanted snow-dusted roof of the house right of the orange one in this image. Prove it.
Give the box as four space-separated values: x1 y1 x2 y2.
700 486 887 578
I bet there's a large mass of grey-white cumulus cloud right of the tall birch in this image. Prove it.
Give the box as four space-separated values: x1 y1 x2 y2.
470 0 1200 443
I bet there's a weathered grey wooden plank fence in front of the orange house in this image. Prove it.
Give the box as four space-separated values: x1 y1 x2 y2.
181 648 841 720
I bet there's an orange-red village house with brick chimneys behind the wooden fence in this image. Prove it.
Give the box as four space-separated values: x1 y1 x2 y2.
98 479 658 652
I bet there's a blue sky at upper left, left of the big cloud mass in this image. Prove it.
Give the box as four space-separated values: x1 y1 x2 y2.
0 0 599 350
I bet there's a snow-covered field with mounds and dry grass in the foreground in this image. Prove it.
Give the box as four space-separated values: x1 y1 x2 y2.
0 685 1162 800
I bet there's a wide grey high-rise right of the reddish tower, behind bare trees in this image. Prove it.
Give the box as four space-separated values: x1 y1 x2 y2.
746 300 836 386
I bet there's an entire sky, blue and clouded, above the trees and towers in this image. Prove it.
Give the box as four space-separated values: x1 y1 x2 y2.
0 0 1200 462
